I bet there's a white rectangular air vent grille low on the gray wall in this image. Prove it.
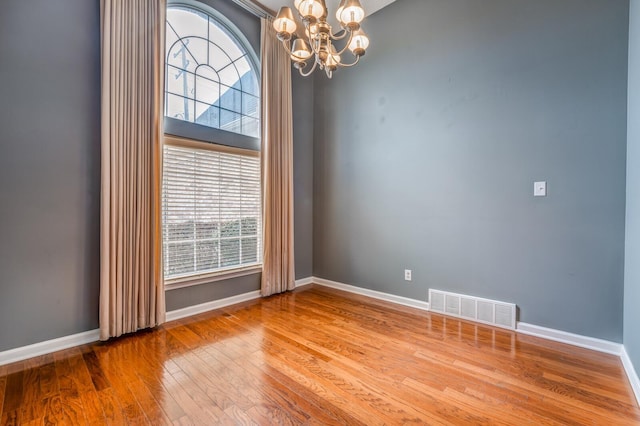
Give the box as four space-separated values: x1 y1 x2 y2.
429 290 516 330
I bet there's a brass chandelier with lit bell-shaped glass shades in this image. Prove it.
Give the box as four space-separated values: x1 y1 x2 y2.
273 0 369 78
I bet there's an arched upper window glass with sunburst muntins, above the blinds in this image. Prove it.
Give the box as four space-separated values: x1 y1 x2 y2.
165 6 260 137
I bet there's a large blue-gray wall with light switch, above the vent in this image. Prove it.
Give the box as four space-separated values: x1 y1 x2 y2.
313 0 628 342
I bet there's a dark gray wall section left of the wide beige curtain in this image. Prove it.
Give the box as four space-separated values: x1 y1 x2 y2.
0 0 100 351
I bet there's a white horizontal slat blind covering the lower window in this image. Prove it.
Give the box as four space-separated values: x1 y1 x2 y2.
162 145 262 279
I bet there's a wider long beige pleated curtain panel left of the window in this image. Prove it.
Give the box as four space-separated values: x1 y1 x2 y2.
100 0 166 340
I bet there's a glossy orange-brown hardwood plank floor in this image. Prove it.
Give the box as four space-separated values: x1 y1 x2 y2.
0 286 640 425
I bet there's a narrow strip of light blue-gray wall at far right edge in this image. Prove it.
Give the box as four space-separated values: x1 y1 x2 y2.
624 0 640 374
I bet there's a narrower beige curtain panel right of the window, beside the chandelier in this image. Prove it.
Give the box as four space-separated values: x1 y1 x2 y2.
261 18 295 296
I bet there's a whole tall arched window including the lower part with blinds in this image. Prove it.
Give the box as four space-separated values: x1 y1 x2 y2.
162 4 262 288
